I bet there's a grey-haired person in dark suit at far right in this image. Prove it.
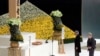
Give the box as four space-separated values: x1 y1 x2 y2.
87 33 96 56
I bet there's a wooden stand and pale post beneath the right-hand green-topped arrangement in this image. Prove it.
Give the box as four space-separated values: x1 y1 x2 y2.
53 27 65 54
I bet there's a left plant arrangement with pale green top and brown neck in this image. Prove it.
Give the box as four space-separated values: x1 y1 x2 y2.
8 18 23 47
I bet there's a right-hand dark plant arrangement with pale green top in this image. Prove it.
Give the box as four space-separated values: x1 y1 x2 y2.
50 10 63 31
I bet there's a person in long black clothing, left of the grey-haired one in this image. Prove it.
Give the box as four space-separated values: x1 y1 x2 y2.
75 30 81 56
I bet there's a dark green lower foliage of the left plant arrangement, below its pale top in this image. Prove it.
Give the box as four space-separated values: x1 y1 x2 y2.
9 24 23 42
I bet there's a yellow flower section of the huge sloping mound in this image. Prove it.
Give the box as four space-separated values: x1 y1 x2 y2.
0 16 75 39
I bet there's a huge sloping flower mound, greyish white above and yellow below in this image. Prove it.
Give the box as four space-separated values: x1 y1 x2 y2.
0 2 75 39
